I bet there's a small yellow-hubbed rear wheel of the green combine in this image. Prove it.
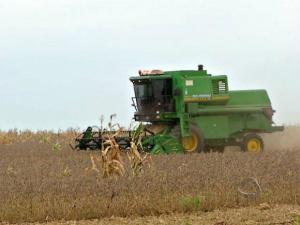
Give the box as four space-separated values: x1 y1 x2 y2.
241 133 264 153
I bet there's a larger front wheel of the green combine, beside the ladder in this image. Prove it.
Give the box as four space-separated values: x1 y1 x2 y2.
170 124 204 153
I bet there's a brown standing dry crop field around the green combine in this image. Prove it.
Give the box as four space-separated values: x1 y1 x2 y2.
0 127 300 222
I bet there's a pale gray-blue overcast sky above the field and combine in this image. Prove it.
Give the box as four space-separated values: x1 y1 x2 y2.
0 0 300 130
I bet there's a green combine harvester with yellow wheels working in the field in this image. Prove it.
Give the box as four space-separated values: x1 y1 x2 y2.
75 65 284 154
